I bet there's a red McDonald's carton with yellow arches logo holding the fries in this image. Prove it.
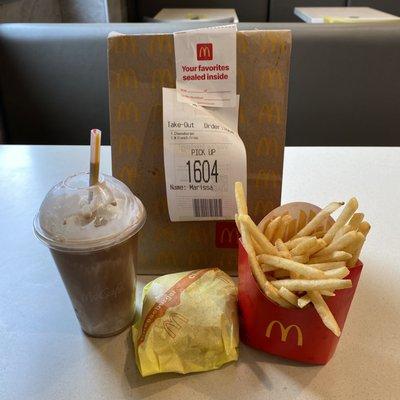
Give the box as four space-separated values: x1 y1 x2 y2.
238 203 363 364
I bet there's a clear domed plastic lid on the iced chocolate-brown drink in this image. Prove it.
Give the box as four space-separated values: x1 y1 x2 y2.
34 173 146 251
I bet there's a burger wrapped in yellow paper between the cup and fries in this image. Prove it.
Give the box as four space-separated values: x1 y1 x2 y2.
132 268 239 376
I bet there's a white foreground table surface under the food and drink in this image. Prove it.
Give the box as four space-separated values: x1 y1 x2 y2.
0 145 400 400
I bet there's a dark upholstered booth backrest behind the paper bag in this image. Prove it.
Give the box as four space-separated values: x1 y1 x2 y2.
0 23 400 146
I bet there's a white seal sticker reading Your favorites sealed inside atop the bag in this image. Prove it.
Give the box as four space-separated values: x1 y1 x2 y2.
174 25 237 107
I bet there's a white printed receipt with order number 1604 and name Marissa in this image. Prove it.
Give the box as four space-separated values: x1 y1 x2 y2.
163 88 247 221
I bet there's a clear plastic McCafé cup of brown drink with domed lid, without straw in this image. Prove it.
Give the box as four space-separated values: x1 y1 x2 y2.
34 173 146 337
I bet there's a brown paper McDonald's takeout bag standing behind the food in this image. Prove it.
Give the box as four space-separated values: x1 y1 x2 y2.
108 31 291 274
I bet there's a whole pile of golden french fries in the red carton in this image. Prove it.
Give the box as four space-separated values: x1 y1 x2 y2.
235 182 371 336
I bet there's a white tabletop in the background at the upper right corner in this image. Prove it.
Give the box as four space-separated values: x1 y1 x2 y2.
294 7 398 24
